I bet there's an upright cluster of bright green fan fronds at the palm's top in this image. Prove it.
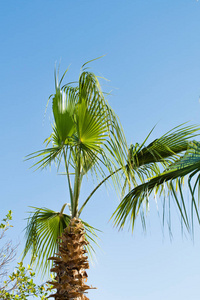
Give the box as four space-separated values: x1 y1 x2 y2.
27 64 128 205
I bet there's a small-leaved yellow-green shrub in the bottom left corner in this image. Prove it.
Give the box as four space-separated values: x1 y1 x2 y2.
0 262 51 300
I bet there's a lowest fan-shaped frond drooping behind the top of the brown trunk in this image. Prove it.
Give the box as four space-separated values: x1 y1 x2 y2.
23 207 98 276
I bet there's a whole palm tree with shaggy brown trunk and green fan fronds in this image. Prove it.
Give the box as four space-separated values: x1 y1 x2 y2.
24 60 200 299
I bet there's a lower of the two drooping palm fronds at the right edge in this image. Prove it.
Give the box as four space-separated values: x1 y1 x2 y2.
112 141 200 230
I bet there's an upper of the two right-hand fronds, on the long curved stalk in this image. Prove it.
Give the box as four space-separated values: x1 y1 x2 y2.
122 124 199 195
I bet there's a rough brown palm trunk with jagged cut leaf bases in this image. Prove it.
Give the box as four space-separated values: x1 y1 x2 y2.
49 218 93 300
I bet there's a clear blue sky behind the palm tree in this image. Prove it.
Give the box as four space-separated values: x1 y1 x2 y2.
0 0 200 300
